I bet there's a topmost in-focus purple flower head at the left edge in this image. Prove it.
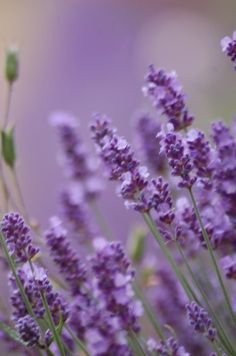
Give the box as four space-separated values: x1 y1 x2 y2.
1 213 39 262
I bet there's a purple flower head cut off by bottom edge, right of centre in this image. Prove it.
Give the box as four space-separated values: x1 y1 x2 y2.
147 337 190 356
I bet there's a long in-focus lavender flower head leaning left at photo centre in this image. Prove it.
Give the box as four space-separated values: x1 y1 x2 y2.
91 114 149 212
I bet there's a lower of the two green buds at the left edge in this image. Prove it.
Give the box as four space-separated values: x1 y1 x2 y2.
1 127 16 169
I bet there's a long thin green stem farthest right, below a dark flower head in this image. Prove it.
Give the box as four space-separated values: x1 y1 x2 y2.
189 189 236 324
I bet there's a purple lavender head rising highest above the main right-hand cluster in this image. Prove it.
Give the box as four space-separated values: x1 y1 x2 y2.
143 65 194 130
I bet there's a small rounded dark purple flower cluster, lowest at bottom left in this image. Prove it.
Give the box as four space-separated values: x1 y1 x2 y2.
16 315 40 346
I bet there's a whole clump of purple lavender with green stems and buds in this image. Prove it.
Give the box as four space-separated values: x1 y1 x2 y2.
0 29 236 356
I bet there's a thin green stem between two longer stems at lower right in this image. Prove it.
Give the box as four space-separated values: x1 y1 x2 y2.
175 240 236 355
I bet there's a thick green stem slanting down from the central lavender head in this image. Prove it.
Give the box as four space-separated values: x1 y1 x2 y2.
142 213 200 304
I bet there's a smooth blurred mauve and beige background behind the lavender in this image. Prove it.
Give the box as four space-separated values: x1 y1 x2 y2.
0 0 236 237
